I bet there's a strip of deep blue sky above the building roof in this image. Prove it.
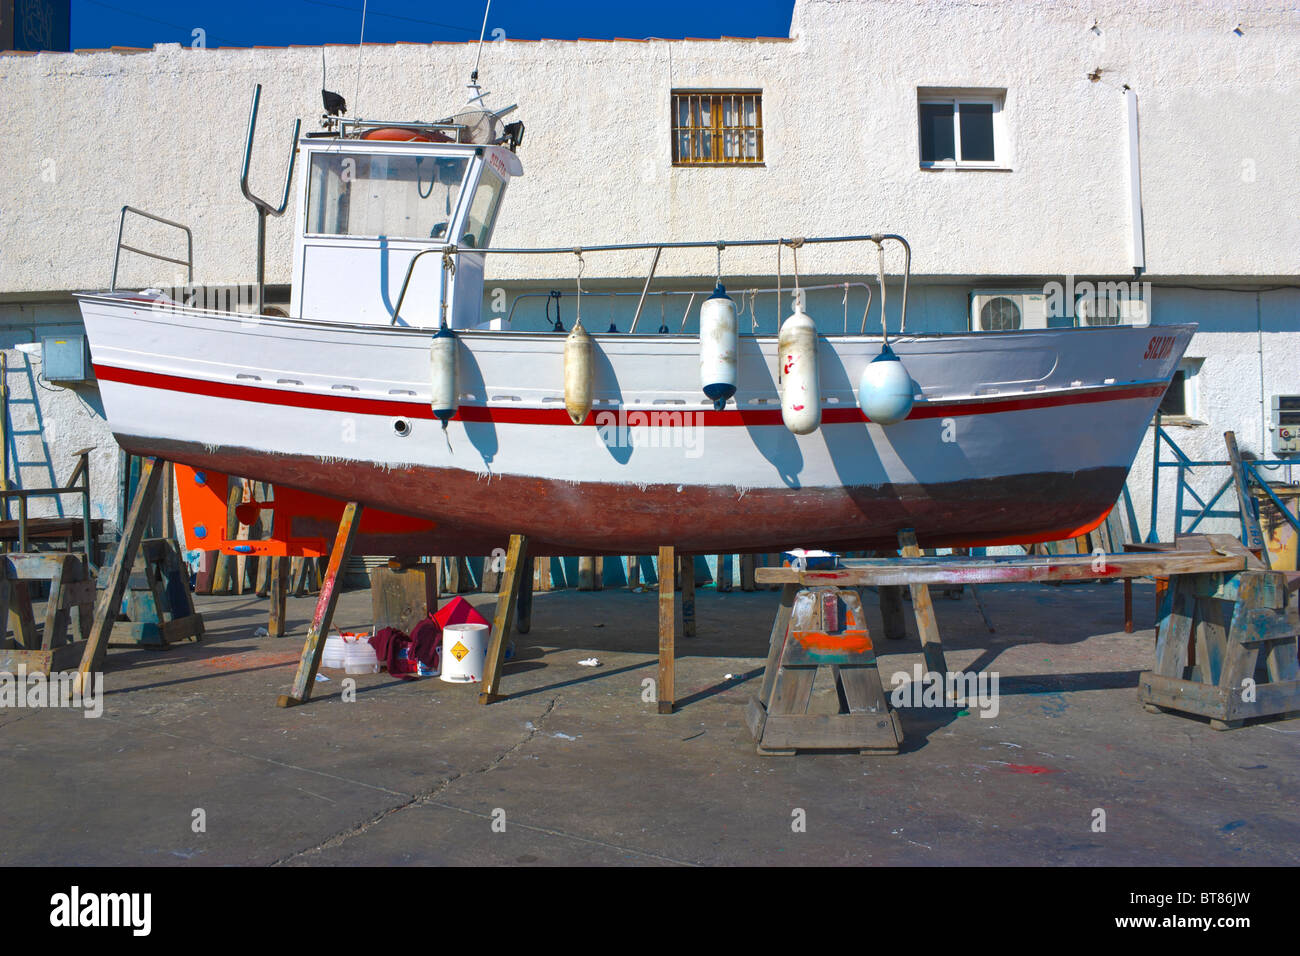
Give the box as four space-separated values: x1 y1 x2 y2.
72 0 794 49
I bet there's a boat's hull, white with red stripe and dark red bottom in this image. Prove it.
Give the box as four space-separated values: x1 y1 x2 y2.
79 294 1195 554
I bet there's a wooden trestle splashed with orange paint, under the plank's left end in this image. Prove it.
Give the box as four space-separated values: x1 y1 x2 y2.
745 584 902 754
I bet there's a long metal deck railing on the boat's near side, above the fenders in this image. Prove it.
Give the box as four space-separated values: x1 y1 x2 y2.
391 233 911 334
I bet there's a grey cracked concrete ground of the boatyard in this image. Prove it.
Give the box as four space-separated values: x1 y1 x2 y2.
0 584 1300 866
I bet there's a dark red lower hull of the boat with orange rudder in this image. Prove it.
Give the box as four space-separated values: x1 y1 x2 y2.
139 436 1127 555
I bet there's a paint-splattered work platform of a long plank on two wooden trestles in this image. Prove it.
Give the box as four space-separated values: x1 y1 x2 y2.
746 535 1300 753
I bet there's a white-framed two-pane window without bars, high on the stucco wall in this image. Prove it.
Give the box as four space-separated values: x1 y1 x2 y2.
917 88 1011 169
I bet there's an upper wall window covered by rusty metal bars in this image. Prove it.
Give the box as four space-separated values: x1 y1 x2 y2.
672 90 763 166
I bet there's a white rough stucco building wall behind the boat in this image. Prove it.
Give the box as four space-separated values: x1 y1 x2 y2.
0 0 1300 533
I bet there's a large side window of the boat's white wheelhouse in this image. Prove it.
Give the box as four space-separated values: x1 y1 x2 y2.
307 152 469 239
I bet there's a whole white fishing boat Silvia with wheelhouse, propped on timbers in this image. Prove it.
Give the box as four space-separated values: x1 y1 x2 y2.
78 91 1195 554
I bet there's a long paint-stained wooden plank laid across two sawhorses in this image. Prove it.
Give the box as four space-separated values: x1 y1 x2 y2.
755 551 1245 588
